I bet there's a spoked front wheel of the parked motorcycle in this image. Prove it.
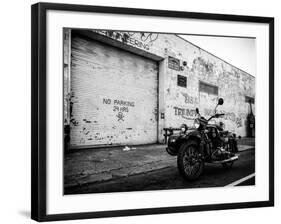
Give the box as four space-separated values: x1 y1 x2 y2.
177 141 204 180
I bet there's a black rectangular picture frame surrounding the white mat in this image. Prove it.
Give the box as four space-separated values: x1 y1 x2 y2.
31 3 274 221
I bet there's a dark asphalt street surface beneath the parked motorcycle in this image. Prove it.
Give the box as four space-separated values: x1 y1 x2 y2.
65 150 255 194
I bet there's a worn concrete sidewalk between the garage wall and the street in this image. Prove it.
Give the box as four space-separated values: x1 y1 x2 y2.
64 139 254 187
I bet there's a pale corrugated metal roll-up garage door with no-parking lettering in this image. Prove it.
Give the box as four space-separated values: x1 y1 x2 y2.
70 35 158 146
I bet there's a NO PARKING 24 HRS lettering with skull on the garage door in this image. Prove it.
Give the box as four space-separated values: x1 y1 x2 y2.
102 98 135 122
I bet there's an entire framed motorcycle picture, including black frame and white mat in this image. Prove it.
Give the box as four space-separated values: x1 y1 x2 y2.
31 3 274 221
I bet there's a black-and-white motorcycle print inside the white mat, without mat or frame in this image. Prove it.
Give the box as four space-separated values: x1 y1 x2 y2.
61 27 257 195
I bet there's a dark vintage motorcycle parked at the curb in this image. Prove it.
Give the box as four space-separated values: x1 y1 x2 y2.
166 98 238 180
